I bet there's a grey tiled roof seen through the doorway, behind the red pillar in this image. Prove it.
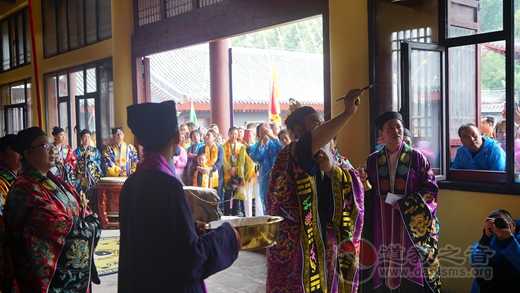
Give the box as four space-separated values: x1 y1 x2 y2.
149 44 323 104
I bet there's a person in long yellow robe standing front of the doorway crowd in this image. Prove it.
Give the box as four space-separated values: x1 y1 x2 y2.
222 127 247 216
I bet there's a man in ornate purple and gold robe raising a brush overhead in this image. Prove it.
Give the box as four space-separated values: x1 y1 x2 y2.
266 90 363 293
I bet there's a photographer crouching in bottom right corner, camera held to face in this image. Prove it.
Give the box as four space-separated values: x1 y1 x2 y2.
470 209 520 293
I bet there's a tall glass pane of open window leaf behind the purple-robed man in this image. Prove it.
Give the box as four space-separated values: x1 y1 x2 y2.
409 50 443 175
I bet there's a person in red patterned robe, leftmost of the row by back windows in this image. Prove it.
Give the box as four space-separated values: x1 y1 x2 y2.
51 127 77 185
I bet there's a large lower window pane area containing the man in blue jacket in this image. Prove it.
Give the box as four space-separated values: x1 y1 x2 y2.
449 41 506 171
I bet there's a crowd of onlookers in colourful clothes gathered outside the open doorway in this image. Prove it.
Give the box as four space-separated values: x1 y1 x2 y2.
170 122 291 217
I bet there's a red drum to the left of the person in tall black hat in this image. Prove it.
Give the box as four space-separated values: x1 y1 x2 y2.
95 177 126 229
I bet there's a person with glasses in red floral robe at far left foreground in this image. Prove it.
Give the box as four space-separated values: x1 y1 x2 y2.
5 127 101 293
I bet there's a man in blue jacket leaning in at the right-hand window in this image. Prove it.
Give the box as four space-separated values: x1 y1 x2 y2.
451 124 506 171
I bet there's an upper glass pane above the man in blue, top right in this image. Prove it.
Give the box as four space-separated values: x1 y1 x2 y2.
448 0 504 37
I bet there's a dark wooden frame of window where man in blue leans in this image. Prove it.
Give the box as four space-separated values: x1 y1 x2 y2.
439 0 520 194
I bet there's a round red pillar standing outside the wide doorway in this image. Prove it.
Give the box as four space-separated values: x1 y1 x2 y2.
209 39 231 137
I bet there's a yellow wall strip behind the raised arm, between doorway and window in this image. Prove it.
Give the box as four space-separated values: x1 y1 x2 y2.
329 0 370 165
